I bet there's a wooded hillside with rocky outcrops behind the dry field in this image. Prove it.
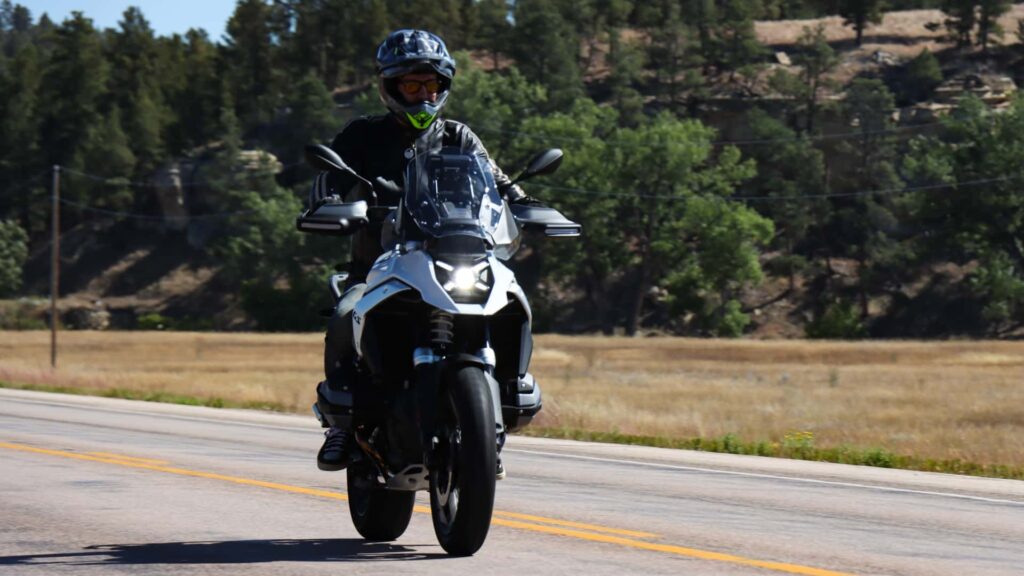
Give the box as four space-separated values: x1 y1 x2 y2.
6 3 1024 338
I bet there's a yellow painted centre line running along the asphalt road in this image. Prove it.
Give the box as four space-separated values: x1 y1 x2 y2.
0 442 852 576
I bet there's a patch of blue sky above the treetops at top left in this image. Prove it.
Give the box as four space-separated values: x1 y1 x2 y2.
25 0 236 41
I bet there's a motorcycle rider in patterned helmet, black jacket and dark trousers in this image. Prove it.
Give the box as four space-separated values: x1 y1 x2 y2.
309 30 536 478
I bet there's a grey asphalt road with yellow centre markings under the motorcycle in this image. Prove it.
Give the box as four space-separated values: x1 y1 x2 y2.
0 389 1024 576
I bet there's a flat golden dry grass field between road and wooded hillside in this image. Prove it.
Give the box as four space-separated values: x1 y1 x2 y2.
0 332 1024 467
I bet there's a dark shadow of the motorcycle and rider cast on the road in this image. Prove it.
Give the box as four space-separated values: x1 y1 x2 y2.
0 538 447 566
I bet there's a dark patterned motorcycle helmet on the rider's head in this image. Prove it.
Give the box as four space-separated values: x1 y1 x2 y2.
377 30 455 130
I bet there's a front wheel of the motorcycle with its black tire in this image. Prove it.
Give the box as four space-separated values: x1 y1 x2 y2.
430 366 498 556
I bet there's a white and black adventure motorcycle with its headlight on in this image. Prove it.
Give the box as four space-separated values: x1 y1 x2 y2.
296 145 581 556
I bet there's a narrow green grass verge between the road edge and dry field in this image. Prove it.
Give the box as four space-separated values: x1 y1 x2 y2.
0 380 1024 480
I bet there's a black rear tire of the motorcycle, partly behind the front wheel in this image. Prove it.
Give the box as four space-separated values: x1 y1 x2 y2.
347 461 416 542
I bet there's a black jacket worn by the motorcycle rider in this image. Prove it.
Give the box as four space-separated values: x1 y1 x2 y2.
310 115 525 283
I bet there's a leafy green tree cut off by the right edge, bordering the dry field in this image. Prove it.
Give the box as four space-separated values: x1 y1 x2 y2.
904 98 1024 333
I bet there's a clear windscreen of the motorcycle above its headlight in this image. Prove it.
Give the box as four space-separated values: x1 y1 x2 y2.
406 149 513 246
